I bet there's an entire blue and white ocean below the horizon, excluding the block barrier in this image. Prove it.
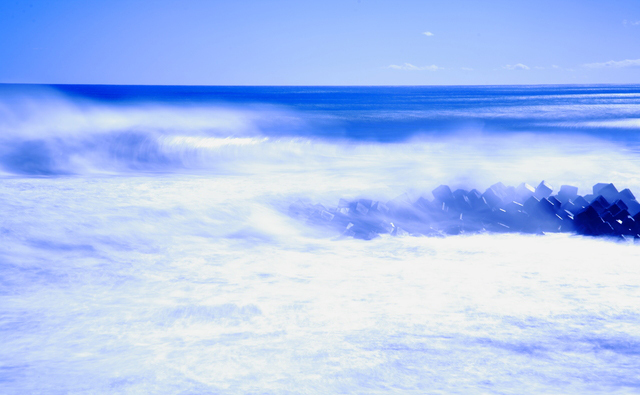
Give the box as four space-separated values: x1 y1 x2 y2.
0 84 640 394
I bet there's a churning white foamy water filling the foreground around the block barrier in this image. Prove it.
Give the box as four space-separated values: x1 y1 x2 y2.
0 164 640 394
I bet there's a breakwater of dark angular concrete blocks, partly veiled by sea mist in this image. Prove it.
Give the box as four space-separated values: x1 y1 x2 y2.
289 181 640 240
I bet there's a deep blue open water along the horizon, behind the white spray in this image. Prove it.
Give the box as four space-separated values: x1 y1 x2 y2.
48 85 640 142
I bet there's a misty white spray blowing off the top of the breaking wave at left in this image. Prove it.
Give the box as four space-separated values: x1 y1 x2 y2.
0 88 302 139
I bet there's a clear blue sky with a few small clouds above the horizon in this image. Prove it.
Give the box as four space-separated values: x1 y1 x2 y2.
0 0 640 85
